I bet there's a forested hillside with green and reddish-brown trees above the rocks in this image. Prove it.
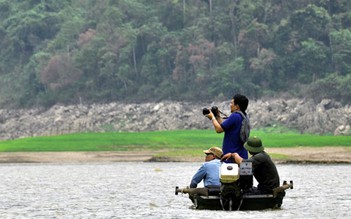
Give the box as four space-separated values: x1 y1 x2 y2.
0 0 351 107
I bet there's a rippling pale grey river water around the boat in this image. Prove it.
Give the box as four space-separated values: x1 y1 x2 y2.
0 162 351 219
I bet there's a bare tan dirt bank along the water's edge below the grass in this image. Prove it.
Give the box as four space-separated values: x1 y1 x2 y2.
0 147 351 163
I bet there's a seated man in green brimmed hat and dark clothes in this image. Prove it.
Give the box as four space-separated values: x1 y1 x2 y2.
222 136 279 194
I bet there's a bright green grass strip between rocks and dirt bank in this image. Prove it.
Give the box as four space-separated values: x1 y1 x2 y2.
0 130 351 152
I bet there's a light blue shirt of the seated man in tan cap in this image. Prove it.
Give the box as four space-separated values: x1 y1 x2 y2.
190 159 221 188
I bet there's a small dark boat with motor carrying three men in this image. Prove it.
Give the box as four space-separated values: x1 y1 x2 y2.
175 163 293 211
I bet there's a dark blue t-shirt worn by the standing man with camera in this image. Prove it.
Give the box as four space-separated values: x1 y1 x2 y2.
221 112 248 159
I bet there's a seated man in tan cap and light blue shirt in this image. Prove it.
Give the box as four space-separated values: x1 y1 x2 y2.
190 147 223 188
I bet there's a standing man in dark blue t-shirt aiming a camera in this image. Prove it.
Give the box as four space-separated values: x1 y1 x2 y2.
205 94 249 159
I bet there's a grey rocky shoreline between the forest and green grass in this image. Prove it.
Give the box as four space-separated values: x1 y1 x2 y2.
0 98 351 140
